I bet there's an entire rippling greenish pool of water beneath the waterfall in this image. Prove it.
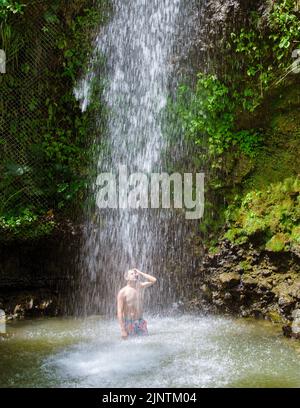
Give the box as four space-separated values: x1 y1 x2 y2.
0 315 300 388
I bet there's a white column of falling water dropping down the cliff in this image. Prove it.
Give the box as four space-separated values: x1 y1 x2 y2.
76 0 199 314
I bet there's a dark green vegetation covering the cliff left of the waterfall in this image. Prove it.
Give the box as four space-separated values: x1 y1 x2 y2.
0 0 109 240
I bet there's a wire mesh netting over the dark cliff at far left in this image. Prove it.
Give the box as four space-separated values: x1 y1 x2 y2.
0 1 62 239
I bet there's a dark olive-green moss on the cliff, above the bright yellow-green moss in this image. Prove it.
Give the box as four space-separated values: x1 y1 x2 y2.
243 80 300 192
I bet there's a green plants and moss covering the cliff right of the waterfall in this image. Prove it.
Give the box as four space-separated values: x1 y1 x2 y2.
175 0 300 251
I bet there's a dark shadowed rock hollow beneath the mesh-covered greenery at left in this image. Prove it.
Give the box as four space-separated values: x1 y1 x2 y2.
0 223 81 319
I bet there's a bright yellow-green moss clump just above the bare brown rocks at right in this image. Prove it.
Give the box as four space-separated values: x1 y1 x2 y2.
225 177 300 252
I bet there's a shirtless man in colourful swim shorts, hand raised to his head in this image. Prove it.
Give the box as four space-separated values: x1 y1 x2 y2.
118 268 156 339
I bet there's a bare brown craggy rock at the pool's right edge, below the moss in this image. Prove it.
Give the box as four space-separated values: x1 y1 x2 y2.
187 240 300 338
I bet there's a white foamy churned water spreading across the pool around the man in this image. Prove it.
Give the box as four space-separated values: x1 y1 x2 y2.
44 316 300 388
